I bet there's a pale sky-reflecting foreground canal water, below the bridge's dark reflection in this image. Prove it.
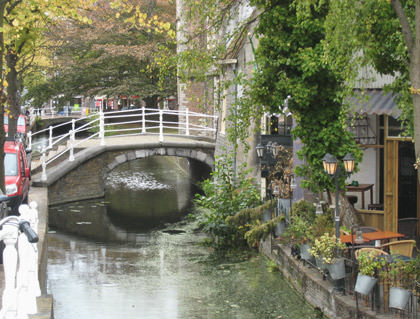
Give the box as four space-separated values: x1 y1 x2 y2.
48 224 316 319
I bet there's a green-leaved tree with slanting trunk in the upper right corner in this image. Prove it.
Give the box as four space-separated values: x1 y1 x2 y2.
325 0 420 185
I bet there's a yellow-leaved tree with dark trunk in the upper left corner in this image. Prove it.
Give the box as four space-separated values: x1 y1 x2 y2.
0 0 95 192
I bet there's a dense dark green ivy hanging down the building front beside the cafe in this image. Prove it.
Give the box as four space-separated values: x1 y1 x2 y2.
251 0 361 192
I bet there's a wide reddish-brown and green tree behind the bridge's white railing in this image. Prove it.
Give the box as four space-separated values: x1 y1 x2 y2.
27 1 176 109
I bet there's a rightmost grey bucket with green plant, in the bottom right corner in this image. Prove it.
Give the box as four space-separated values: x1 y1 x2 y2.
383 257 420 310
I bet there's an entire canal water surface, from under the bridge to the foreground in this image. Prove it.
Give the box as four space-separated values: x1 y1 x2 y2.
47 157 319 319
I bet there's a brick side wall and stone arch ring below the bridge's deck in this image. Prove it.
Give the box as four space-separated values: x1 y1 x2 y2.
39 146 214 205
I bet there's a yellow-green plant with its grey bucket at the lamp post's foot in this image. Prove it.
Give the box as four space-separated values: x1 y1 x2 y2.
309 232 346 280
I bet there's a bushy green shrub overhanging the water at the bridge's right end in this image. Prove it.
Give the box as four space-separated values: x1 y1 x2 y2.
194 155 260 246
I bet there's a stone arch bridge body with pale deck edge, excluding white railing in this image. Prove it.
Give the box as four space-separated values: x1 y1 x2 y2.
32 135 215 205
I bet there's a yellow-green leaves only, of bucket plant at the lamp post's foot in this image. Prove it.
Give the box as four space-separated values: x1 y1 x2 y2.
309 233 345 264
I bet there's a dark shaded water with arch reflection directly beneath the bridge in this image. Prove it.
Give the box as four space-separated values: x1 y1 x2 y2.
49 157 194 242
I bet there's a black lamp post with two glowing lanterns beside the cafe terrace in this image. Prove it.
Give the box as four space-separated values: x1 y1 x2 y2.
322 153 354 241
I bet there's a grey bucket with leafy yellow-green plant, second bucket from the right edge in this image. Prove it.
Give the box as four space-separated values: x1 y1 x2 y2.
354 251 386 295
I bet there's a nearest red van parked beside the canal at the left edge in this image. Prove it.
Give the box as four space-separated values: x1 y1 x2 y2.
4 138 31 214
